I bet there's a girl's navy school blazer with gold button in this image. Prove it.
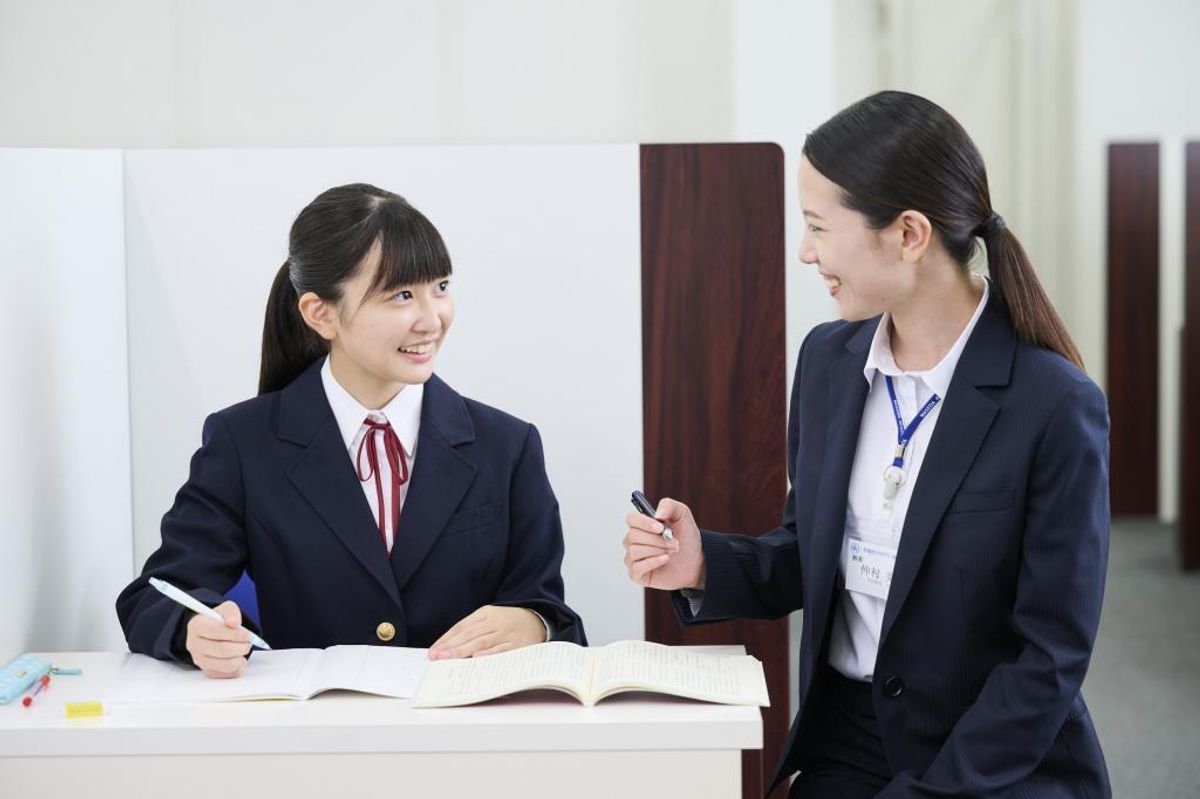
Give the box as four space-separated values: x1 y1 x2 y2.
116 361 586 662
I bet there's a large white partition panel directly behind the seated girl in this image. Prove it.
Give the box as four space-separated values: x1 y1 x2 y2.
126 145 643 643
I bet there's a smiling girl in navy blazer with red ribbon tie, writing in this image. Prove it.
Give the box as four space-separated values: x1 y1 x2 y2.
116 184 584 677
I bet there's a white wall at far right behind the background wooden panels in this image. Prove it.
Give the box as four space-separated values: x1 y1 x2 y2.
1070 0 1200 521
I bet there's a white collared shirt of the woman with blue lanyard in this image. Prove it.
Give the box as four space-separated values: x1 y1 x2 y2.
829 280 991 680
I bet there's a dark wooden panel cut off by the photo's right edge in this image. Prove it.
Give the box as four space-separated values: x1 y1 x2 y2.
1180 142 1200 571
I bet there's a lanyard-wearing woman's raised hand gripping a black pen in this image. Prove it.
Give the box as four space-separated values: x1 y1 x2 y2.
623 499 704 591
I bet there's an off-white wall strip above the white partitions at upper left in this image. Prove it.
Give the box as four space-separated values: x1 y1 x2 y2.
0 0 739 146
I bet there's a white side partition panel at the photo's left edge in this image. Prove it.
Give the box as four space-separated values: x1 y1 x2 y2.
0 149 133 662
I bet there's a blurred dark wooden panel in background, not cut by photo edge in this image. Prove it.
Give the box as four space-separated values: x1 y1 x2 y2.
1108 144 1159 516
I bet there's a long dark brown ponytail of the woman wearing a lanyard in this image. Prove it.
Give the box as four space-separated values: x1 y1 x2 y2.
976 212 1084 370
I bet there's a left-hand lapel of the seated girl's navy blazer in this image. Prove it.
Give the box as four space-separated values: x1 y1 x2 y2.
276 361 400 603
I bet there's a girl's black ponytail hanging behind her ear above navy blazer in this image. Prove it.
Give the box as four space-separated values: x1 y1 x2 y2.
258 260 329 394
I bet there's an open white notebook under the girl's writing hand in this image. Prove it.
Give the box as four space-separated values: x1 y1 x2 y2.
109 645 428 702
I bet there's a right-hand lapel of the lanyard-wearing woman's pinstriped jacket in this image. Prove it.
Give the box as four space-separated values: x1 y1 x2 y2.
880 292 1016 648
